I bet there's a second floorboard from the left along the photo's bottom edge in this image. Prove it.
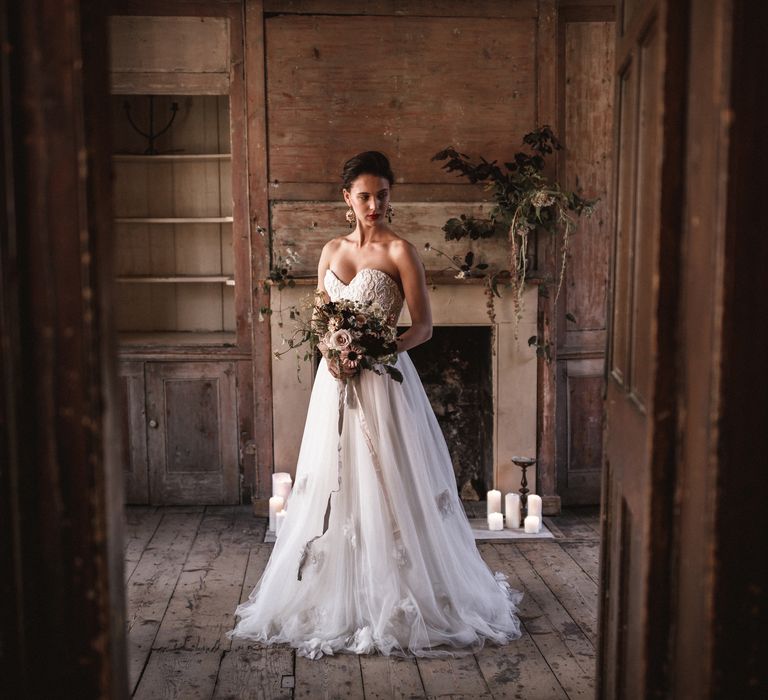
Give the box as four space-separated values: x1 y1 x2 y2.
213 644 294 700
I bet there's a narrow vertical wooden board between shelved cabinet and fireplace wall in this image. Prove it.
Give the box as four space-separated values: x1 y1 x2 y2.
244 0 274 504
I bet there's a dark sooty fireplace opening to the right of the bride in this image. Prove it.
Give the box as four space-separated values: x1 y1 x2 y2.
400 326 493 513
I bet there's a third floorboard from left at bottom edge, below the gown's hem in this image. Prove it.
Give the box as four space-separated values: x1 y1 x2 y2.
294 654 364 700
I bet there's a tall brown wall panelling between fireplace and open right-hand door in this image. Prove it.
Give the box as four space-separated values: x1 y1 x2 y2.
556 8 615 505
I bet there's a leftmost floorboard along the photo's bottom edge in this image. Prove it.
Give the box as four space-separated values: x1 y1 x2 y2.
133 650 221 700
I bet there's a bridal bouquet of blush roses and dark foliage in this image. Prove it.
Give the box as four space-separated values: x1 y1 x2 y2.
275 291 403 382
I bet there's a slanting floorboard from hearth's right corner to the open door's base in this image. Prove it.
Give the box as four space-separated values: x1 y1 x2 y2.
517 543 597 646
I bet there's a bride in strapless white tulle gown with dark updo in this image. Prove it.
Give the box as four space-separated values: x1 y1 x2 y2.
228 151 522 659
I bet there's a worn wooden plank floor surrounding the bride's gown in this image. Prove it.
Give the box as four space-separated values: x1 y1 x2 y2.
125 506 600 700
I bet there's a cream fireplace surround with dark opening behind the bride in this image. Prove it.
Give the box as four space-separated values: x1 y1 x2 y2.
272 281 537 506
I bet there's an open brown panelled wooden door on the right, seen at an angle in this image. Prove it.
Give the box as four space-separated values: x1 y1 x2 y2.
599 0 686 698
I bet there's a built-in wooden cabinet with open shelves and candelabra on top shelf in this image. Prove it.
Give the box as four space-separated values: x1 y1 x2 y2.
111 15 255 504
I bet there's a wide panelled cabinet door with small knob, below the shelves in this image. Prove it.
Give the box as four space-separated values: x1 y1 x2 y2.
146 362 239 505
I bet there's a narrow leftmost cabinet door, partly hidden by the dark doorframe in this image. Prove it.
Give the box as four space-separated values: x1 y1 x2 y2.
119 361 149 505
